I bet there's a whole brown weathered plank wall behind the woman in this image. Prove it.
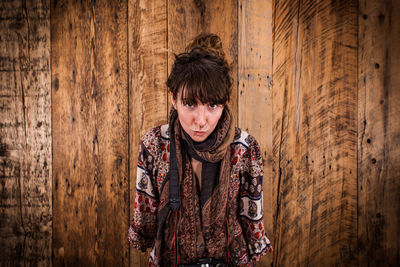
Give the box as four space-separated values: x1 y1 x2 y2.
0 0 400 266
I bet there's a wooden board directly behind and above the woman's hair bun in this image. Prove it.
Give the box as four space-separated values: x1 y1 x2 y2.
168 0 238 120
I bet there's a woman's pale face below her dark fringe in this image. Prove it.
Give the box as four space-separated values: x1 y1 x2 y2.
171 93 224 142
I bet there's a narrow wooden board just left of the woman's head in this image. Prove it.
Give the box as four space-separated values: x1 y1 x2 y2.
128 0 167 266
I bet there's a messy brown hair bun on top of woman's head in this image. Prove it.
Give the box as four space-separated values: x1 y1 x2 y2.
186 33 225 61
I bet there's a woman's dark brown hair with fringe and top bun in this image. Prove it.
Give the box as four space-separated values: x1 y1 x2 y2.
167 33 232 104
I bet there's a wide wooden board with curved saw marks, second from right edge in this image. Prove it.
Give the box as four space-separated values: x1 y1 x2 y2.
273 0 357 266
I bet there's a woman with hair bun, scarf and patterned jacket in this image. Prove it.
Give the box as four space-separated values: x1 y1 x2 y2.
129 34 272 266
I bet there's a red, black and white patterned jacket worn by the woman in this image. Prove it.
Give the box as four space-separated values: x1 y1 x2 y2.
128 124 271 266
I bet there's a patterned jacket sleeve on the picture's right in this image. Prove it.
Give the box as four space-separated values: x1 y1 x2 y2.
239 135 272 261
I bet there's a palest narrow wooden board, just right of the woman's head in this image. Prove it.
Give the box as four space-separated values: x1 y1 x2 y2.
238 1 273 266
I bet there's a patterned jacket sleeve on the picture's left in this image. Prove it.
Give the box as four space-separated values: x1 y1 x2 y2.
128 142 158 251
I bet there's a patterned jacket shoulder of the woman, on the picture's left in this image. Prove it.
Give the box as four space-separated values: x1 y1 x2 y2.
140 124 169 155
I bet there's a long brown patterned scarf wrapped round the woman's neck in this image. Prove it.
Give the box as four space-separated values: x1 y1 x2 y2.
154 106 234 266
